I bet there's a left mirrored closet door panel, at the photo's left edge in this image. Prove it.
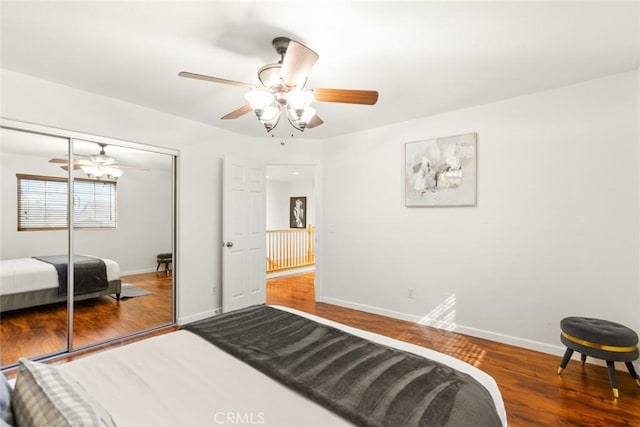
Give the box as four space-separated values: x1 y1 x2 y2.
0 129 69 366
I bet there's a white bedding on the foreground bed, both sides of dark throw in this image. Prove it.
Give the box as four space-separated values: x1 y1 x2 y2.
60 307 507 427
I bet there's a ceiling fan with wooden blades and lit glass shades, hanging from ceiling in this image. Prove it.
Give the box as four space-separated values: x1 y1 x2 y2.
178 37 378 132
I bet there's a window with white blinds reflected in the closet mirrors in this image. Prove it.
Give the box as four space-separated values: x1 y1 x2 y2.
17 174 116 231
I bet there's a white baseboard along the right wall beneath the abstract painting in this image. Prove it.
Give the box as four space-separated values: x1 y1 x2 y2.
318 297 640 372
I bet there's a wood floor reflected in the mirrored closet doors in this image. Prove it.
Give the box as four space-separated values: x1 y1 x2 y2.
0 272 172 366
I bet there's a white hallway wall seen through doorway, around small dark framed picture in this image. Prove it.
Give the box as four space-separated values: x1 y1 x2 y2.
267 179 316 230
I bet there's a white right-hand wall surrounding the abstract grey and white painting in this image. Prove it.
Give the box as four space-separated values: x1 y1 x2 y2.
320 71 640 353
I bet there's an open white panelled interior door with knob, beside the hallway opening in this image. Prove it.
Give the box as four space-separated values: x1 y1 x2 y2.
222 156 267 312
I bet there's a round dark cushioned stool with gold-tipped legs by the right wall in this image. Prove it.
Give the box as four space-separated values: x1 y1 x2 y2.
558 317 640 398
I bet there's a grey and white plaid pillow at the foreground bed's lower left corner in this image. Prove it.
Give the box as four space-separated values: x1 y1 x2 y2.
13 358 115 427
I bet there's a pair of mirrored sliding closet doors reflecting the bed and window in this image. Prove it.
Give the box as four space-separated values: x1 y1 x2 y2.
0 121 177 367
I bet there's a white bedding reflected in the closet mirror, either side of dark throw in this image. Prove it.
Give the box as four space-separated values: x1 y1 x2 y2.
0 258 120 295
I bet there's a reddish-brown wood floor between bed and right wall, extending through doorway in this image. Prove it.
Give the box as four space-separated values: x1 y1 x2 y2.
267 273 640 427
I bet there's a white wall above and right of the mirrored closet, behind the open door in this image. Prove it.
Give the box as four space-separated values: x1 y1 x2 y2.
0 70 322 323
